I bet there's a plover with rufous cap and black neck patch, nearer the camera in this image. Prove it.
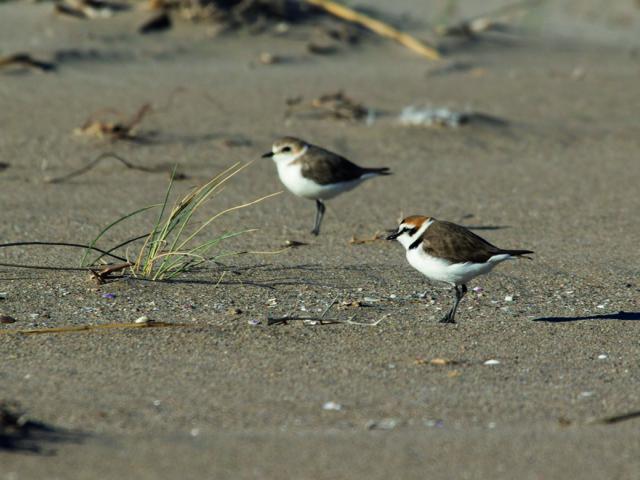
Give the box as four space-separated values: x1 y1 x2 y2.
387 215 533 323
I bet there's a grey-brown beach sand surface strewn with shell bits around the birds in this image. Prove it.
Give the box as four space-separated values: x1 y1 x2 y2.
0 0 640 480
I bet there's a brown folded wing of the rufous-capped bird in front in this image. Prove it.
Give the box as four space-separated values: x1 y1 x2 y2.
422 220 508 263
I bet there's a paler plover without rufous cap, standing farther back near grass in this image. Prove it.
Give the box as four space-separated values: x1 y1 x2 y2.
262 137 391 235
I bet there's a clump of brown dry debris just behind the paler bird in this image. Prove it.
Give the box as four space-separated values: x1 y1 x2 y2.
286 91 372 121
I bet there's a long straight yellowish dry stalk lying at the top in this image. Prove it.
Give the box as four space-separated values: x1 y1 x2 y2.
306 0 441 60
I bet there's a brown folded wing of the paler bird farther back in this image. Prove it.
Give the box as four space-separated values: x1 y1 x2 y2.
302 146 369 185
